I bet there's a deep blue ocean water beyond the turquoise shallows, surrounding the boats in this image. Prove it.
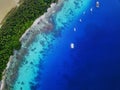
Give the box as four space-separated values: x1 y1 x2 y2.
12 0 120 90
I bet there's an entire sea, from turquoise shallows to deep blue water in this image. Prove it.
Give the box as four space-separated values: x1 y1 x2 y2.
13 0 120 90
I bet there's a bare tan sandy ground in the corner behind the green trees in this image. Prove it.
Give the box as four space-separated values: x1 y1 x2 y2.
0 0 19 24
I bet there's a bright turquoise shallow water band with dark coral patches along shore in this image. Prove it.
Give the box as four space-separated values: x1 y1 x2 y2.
14 0 90 90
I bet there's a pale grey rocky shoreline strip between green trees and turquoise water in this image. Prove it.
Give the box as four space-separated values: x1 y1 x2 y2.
0 0 63 90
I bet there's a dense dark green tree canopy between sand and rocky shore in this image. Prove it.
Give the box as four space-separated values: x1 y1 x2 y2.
0 0 56 80
